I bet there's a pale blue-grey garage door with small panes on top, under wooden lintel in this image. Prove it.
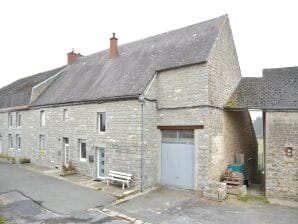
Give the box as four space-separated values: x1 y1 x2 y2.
161 130 194 190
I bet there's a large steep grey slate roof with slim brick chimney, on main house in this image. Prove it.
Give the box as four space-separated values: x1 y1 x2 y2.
33 15 228 105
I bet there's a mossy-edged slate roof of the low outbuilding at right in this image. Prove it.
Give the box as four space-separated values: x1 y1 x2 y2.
226 67 298 110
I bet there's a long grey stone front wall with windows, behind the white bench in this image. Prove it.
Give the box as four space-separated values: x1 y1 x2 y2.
0 100 157 186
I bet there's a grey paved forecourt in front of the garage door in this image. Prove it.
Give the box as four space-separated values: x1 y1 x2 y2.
109 188 298 224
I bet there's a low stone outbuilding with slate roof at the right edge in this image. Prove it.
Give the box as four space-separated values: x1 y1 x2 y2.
226 67 298 203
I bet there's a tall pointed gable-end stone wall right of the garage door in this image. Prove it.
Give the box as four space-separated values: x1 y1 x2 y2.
208 18 255 181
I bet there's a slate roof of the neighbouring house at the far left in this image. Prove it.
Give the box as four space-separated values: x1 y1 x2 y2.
0 66 65 108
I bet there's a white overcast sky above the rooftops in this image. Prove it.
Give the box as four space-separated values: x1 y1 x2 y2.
0 0 298 92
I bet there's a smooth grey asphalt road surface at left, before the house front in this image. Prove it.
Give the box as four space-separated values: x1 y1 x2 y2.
0 163 115 214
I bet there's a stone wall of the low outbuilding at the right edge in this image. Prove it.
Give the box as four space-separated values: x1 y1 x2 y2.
265 112 298 202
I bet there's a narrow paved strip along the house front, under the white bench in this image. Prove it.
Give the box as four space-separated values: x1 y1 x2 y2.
19 163 139 200
